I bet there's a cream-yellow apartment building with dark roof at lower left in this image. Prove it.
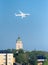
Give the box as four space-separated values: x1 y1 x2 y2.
0 52 14 65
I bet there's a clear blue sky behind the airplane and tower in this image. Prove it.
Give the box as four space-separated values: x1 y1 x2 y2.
0 0 48 51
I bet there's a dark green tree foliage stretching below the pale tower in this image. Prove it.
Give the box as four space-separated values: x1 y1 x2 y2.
0 49 48 65
